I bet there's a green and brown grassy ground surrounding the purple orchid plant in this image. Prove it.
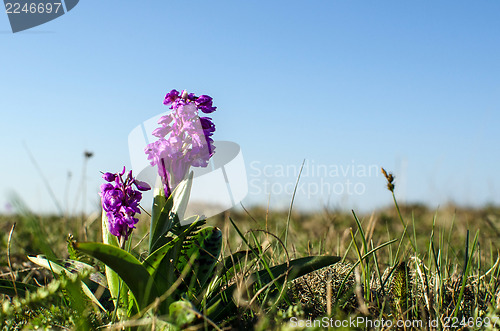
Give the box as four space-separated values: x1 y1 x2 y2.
0 198 500 330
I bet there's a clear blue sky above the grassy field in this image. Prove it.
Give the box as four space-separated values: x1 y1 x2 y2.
0 0 500 215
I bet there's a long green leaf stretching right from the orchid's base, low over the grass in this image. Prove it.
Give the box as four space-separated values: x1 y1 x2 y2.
206 256 342 322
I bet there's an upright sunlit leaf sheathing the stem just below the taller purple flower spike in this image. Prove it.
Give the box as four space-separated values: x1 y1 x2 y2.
149 172 193 253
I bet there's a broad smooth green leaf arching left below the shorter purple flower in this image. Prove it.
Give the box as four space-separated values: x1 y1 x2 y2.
74 243 159 310
